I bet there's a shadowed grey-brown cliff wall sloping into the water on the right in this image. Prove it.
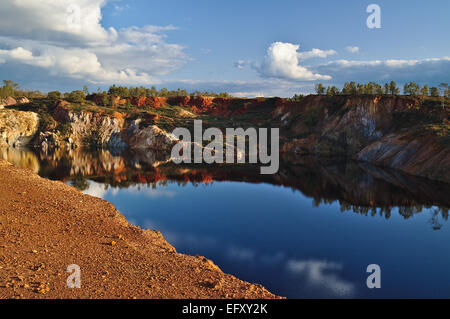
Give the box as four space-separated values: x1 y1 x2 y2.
280 96 450 182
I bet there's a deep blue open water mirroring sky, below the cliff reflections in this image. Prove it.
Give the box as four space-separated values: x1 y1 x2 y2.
91 182 450 297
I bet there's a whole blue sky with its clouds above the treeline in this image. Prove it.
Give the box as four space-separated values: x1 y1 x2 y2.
0 0 450 96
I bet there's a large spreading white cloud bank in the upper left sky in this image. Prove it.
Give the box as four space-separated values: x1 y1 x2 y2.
0 0 188 84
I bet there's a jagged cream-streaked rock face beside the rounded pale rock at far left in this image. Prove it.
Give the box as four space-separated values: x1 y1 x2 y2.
34 105 178 154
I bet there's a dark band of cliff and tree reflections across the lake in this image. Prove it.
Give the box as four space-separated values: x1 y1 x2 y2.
0 149 450 222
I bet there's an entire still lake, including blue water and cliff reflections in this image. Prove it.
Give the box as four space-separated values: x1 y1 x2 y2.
0 149 450 298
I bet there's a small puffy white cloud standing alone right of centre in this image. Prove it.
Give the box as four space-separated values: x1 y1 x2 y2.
255 42 331 81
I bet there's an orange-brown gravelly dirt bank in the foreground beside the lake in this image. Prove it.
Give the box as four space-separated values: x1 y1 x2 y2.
0 160 275 298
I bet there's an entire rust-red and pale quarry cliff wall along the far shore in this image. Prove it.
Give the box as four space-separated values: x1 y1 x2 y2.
0 95 450 182
